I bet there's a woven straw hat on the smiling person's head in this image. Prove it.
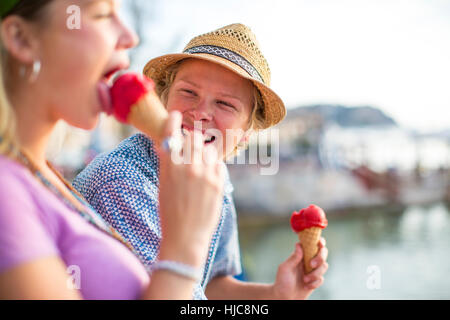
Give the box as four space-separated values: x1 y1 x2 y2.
144 24 286 129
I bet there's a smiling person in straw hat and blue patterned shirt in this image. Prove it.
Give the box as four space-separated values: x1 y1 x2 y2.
74 24 328 299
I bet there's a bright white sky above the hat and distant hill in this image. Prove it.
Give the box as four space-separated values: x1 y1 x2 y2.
123 0 450 132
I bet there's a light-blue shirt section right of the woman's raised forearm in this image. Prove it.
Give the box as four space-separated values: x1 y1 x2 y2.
209 171 242 279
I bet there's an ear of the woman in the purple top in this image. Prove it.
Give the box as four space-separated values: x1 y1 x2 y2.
1 16 36 65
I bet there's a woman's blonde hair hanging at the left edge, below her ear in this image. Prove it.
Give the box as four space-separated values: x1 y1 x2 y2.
0 39 18 156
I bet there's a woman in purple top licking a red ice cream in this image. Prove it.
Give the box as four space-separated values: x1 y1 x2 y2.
0 0 223 299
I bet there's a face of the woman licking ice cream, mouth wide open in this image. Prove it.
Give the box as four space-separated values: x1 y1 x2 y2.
4 0 137 129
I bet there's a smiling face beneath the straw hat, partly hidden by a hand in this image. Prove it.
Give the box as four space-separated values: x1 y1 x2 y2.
166 59 254 158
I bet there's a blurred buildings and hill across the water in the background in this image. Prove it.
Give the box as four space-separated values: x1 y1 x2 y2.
229 105 450 216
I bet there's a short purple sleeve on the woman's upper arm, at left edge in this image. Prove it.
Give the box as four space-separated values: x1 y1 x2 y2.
0 173 59 272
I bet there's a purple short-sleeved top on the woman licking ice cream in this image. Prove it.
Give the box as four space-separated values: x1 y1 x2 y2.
0 155 150 299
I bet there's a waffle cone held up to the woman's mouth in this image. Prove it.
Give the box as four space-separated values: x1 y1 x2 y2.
127 91 169 142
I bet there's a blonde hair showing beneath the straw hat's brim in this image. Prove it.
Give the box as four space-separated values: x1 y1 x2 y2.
155 60 265 155
